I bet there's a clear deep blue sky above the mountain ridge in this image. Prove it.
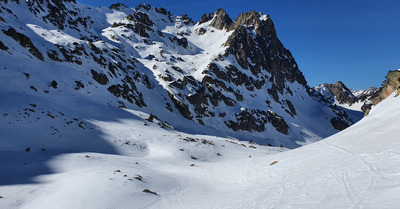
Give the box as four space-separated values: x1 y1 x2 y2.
78 0 400 90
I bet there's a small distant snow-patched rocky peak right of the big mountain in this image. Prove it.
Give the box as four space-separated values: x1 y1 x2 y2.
314 81 379 113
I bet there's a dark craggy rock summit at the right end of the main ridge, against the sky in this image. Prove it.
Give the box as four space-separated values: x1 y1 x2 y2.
225 11 308 101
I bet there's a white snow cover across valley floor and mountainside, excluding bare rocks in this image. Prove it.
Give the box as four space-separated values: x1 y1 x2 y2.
0 2 400 209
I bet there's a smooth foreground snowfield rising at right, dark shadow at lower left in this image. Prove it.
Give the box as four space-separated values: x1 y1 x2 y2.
0 93 400 209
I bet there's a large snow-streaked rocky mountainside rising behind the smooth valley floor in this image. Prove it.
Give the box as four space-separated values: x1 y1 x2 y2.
0 0 355 147
